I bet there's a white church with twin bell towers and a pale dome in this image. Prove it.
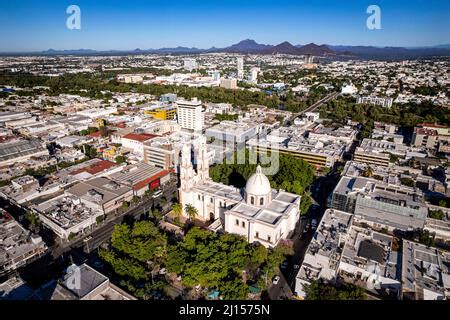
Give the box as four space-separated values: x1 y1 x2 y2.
179 139 301 247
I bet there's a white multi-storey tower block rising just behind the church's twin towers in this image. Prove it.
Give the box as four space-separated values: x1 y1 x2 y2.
177 98 205 131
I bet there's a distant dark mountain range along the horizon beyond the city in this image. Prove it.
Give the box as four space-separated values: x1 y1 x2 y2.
1 39 450 60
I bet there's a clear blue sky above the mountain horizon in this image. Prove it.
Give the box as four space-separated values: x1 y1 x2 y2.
0 0 450 52
